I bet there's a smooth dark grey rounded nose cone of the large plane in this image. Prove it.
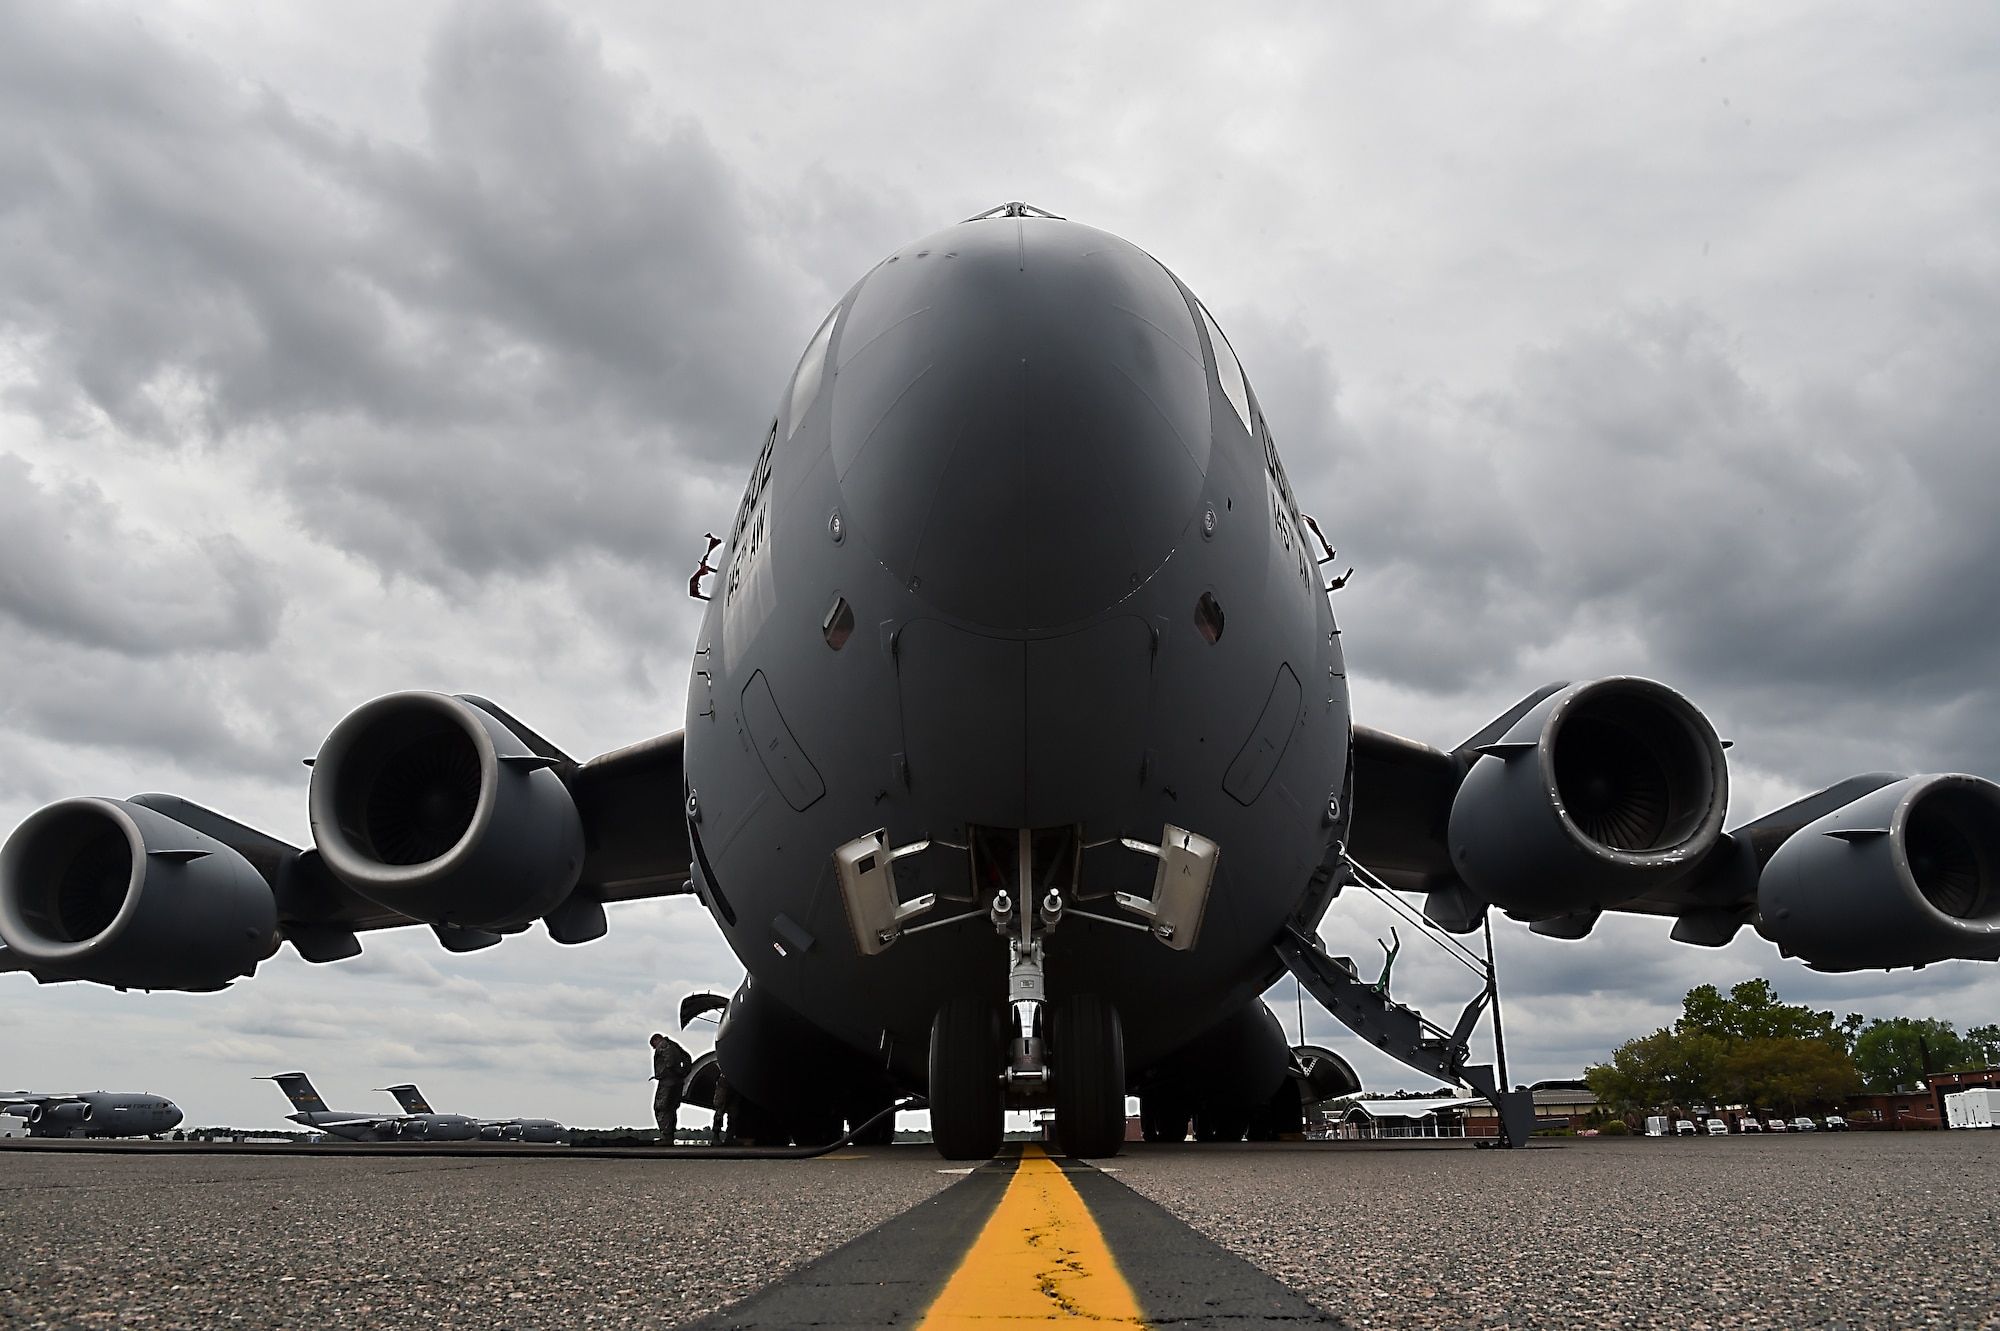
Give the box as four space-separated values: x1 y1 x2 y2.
832 218 1210 630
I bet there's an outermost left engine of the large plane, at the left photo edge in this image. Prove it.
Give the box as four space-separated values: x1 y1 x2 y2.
0 799 278 989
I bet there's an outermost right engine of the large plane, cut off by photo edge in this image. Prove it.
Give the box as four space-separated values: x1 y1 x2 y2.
1756 775 2000 971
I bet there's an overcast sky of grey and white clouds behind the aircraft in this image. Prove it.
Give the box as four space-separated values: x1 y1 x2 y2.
0 0 2000 1125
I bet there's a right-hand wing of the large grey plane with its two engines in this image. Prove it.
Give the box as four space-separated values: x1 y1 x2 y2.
1346 677 2000 971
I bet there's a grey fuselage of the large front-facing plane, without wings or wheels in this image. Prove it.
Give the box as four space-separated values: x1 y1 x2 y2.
686 216 1348 1111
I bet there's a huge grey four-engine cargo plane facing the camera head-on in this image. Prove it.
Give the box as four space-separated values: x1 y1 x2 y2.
0 204 2000 1159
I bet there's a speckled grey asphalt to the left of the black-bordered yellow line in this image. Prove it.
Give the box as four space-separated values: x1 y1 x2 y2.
0 1145 958 1331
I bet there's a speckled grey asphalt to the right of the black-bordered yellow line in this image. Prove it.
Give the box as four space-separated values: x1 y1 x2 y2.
1112 1131 2000 1331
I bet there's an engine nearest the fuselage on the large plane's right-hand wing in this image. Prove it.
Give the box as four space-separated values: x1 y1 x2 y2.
1448 675 1728 919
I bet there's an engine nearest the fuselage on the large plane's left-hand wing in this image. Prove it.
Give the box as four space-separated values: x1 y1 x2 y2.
308 693 584 929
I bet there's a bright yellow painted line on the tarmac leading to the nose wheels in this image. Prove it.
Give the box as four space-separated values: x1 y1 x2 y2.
918 1143 1146 1331
